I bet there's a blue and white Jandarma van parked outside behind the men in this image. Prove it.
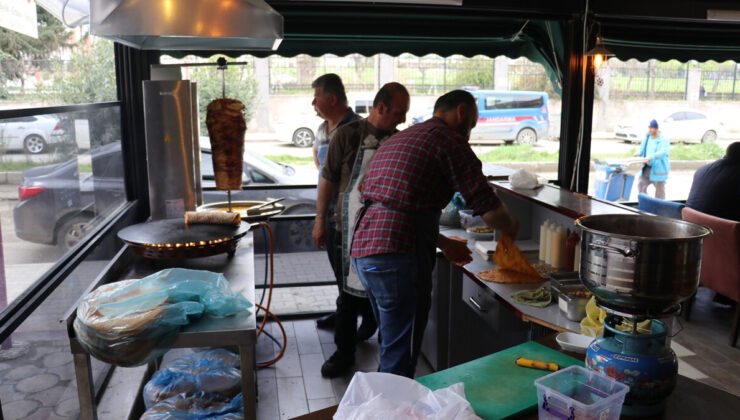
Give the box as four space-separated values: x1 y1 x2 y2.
411 89 550 144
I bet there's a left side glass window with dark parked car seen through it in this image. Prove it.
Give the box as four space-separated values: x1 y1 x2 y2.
0 8 127 419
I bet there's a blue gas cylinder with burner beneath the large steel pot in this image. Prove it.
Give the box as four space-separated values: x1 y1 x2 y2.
586 315 678 416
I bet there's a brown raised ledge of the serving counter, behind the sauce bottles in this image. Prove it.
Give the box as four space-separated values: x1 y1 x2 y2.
491 181 639 219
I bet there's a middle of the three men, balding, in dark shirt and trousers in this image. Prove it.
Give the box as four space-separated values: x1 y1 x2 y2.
313 83 409 378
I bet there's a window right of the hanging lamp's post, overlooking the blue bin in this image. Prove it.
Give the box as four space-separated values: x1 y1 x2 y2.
589 58 740 202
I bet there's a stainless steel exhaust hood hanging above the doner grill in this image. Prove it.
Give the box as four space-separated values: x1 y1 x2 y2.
90 0 283 50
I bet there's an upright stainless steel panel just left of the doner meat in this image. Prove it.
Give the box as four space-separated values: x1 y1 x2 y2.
143 80 195 220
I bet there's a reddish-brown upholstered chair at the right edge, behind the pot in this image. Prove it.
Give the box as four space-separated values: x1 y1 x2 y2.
681 207 740 347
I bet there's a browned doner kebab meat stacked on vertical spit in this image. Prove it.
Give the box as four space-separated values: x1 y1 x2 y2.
206 98 247 190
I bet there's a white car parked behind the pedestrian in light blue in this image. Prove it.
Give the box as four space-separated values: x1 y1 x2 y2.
614 110 723 143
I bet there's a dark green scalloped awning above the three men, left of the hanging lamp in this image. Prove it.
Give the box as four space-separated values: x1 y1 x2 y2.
166 13 566 93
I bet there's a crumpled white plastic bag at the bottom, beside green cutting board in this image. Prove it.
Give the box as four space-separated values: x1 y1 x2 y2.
334 372 480 420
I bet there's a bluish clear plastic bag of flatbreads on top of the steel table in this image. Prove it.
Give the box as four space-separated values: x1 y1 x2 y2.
74 268 252 366
